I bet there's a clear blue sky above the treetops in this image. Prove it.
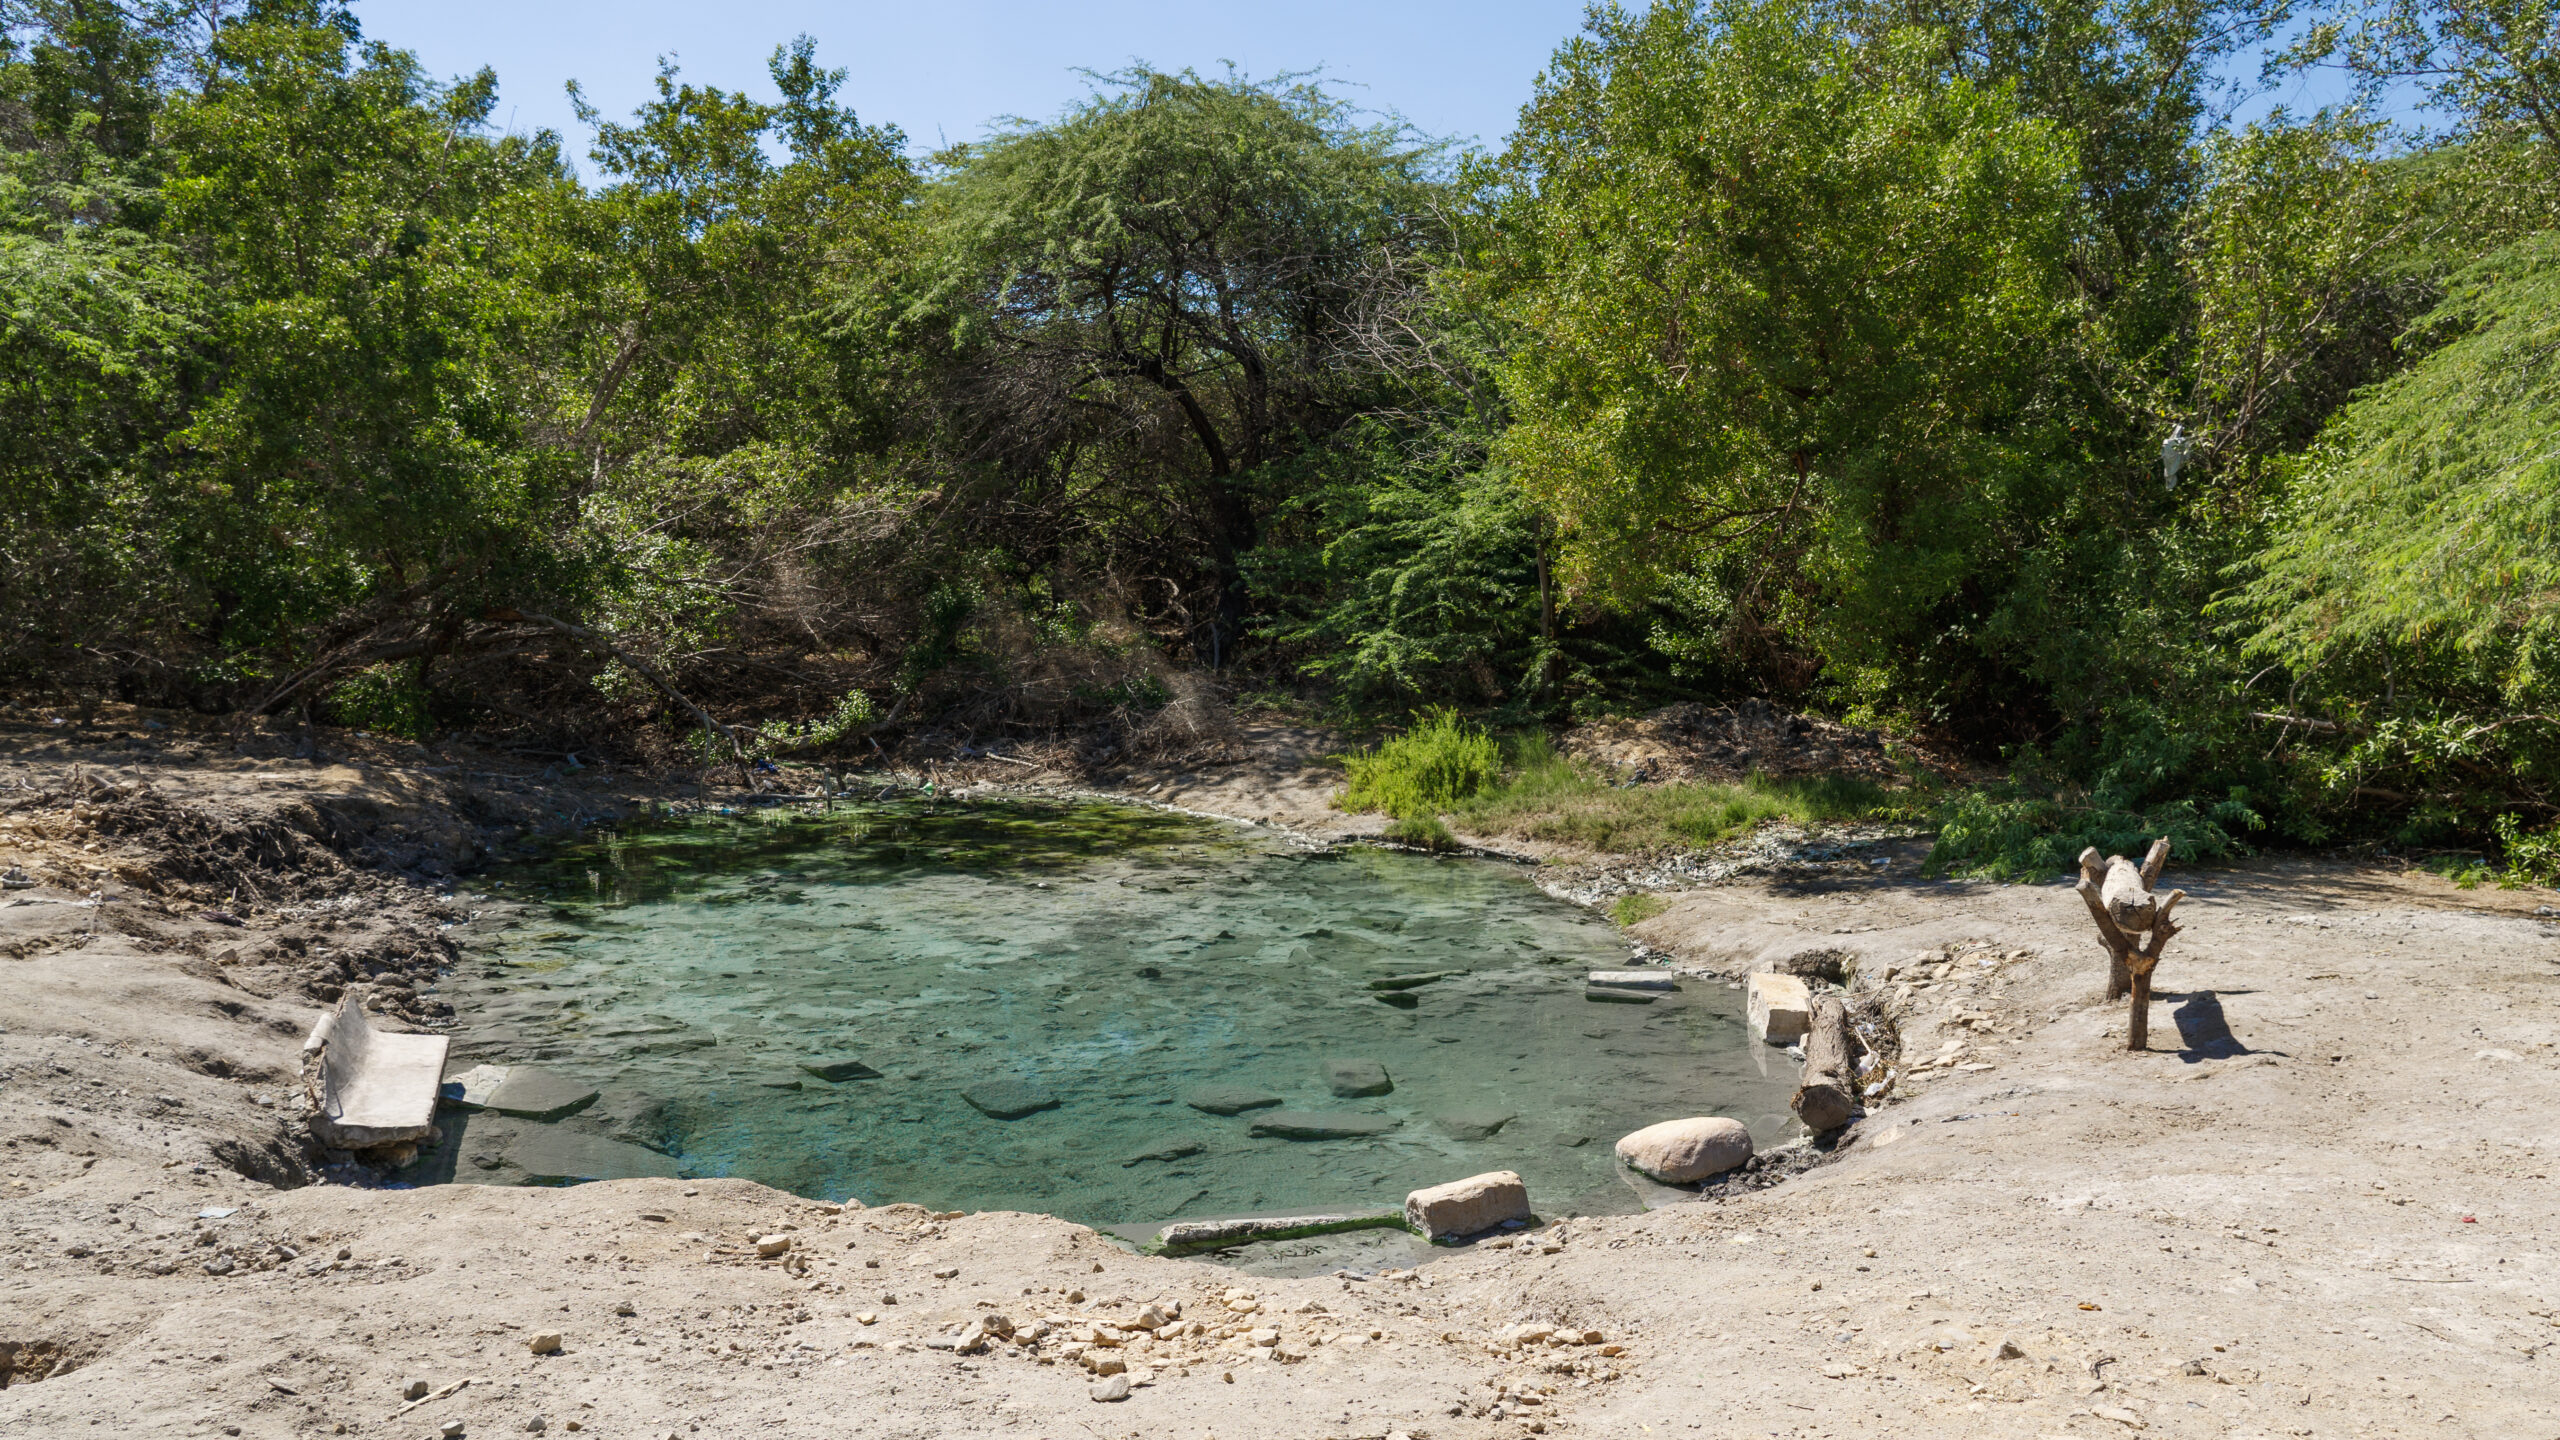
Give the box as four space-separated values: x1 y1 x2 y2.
356 0 2396 174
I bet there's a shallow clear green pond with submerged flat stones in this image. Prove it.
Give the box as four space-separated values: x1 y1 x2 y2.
443 799 1795 1225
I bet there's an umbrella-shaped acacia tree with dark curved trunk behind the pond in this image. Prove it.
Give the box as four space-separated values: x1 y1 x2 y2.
922 69 1439 659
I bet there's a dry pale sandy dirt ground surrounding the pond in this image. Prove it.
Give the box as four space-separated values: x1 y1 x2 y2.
0 715 2560 1440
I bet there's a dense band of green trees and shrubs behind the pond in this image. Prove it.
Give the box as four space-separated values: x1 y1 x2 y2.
0 0 2560 874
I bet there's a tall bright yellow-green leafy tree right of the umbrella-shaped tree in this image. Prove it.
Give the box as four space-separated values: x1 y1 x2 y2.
1472 0 2074 691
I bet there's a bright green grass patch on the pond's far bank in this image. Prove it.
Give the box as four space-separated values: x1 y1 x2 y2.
1339 710 1912 853
